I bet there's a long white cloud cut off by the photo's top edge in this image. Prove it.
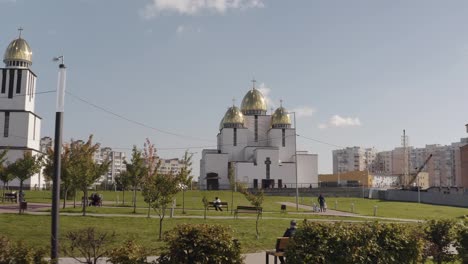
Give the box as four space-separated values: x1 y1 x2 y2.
141 0 264 18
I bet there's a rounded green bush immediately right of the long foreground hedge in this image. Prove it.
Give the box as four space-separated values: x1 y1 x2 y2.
424 219 457 263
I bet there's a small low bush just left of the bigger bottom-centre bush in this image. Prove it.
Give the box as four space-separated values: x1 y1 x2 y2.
107 240 150 264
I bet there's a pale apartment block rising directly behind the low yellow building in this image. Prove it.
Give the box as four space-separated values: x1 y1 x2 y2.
333 147 378 174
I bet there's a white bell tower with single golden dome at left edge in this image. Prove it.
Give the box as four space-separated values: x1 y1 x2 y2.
0 31 45 188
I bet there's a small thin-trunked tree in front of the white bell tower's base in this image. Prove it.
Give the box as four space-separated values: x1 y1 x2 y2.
8 151 42 213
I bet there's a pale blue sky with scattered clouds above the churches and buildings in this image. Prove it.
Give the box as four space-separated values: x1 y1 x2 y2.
0 0 468 176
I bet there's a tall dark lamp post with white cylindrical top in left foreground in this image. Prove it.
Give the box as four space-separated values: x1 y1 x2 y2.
50 56 67 263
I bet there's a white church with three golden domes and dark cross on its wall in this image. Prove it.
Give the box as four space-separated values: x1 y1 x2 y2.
199 82 318 190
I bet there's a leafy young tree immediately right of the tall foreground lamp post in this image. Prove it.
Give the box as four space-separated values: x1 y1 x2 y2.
68 135 110 216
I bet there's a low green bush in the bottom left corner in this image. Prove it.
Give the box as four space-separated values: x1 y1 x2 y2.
0 236 47 264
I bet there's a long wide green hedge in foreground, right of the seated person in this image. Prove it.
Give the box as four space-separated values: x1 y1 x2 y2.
286 221 422 264
